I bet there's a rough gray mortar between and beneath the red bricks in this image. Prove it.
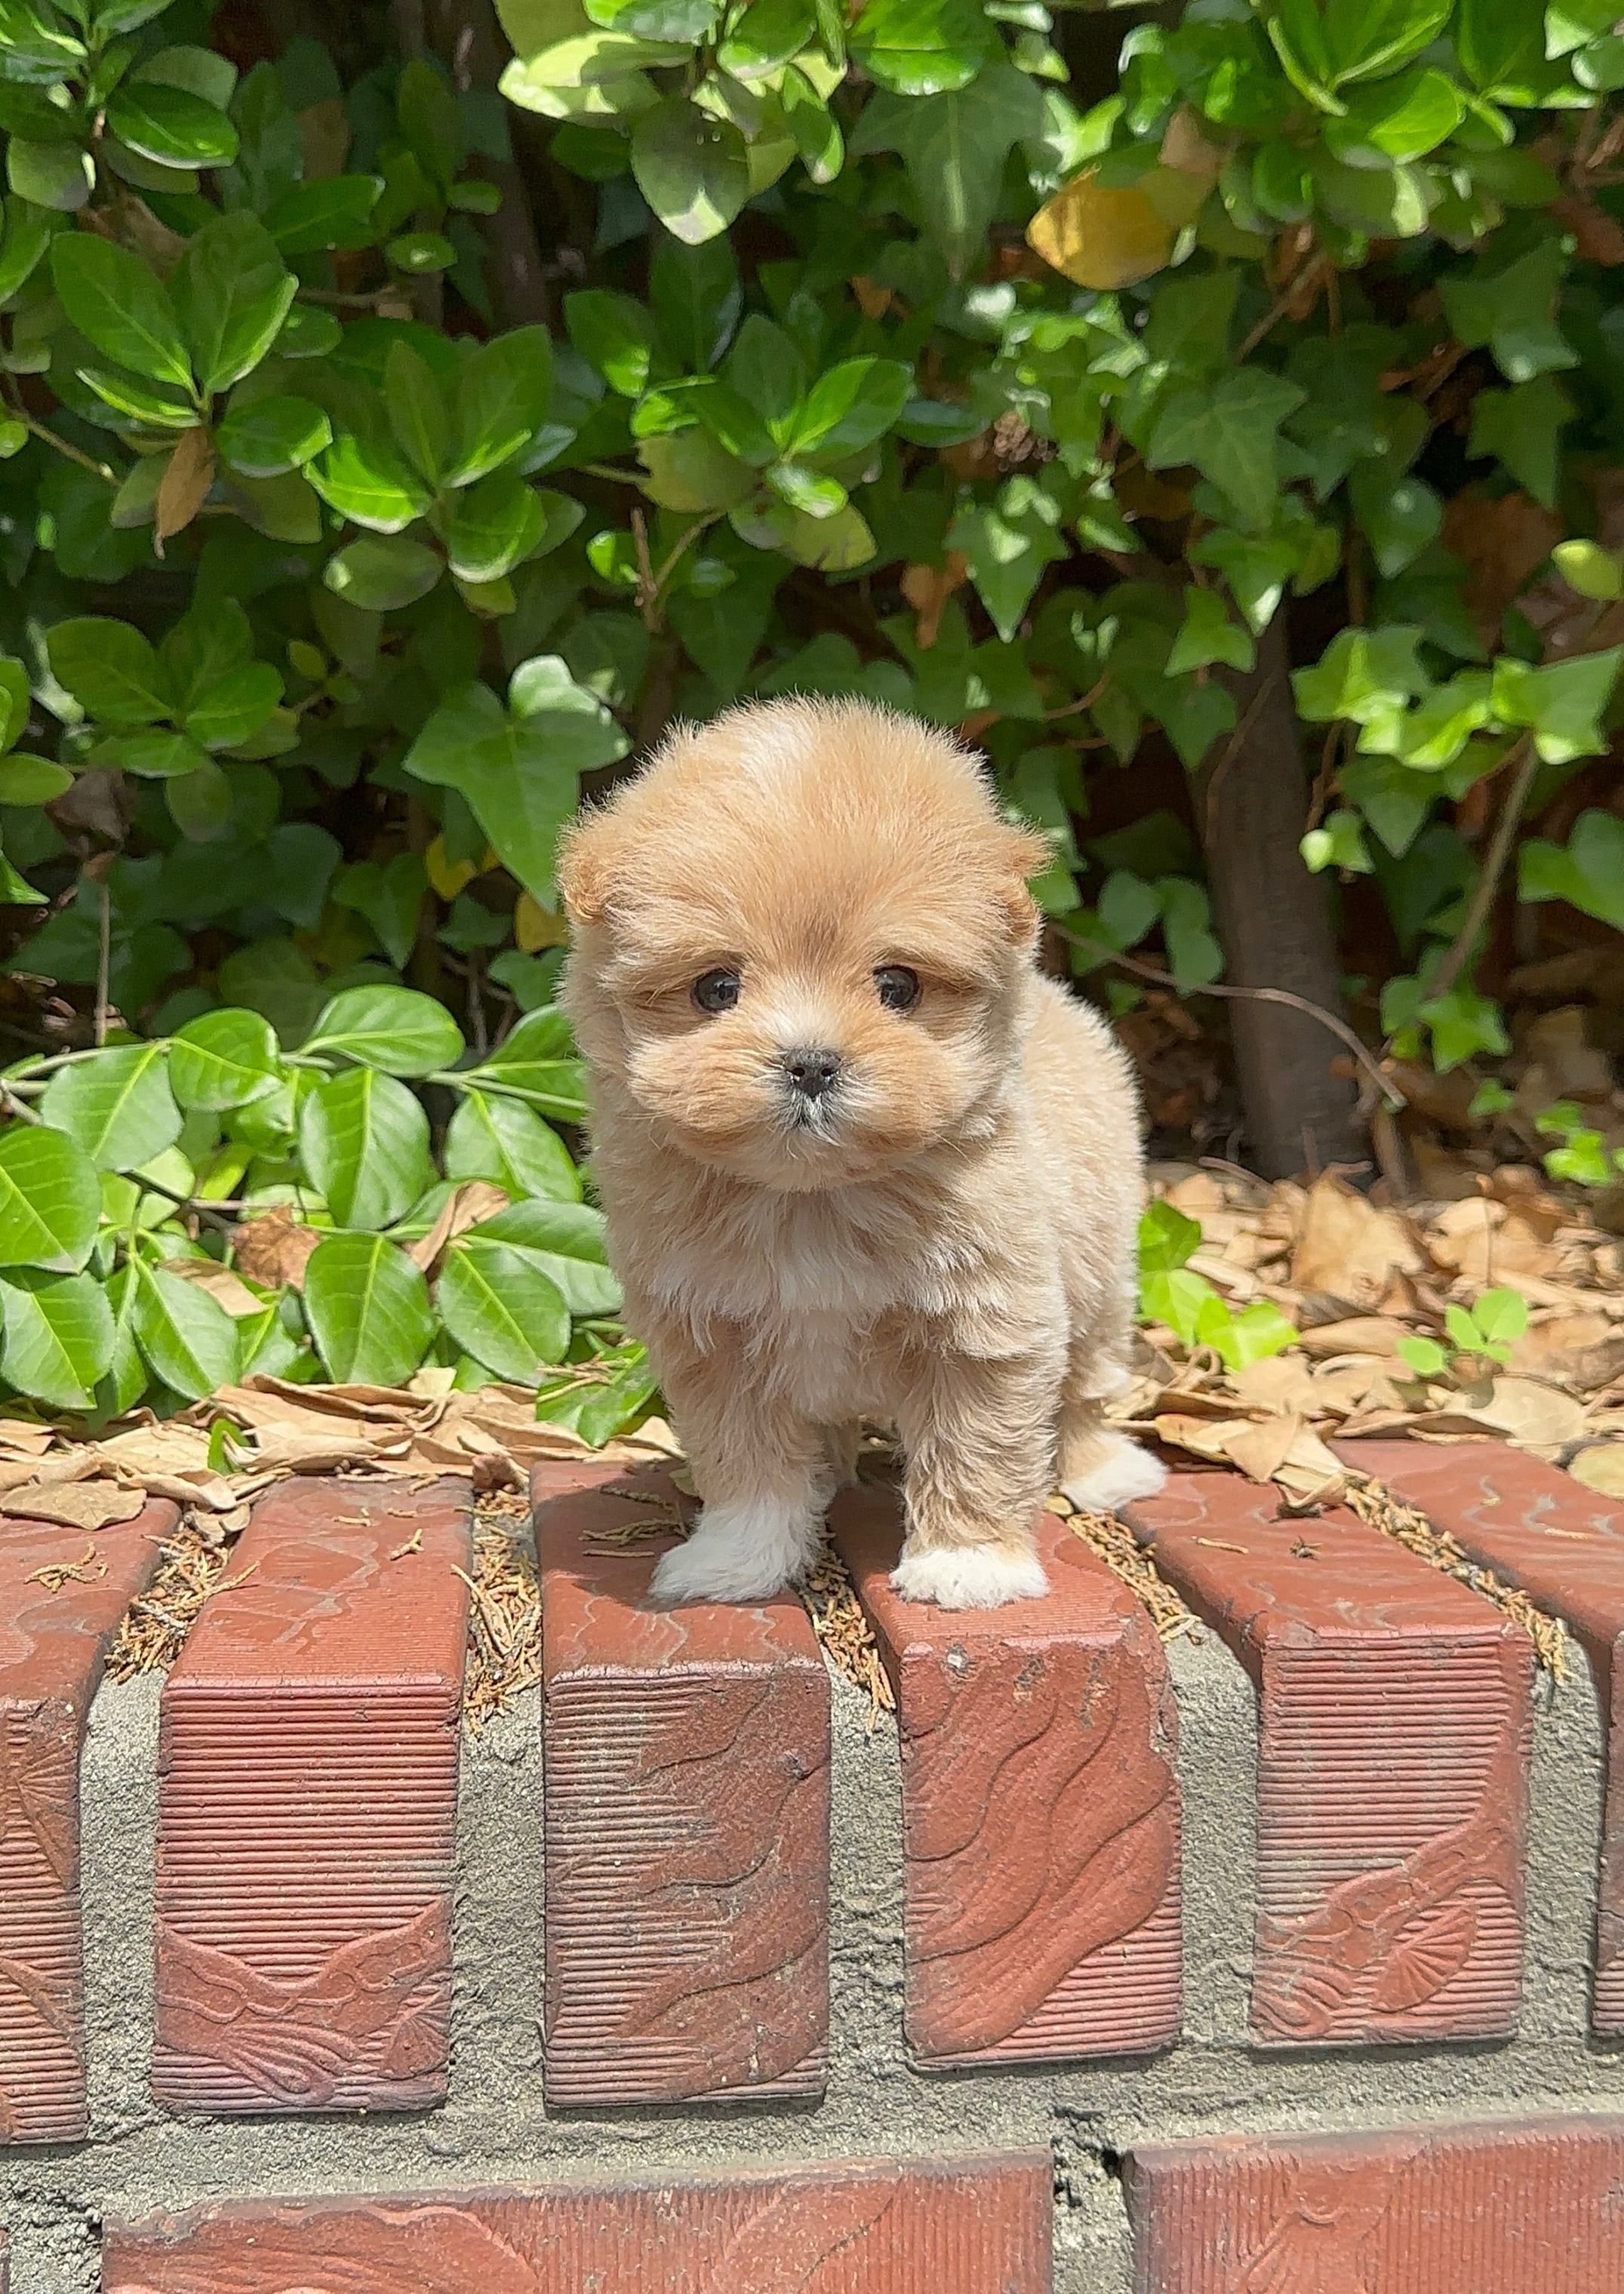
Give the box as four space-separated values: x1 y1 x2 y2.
0 1633 1624 2294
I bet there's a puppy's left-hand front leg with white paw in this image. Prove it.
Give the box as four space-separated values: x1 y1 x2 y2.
652 1353 830 1602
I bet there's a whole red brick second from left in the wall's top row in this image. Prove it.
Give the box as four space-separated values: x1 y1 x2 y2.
152 1482 470 2111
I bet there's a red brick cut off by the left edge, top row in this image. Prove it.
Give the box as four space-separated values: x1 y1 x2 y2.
0 1503 174 2145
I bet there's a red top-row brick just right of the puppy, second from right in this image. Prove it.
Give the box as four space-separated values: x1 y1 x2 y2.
1129 1472 1532 2046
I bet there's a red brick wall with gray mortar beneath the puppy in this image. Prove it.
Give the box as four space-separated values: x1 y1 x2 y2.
0 1445 1624 2294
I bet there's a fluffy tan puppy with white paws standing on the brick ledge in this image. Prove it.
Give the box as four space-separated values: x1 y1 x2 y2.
559 702 1163 1608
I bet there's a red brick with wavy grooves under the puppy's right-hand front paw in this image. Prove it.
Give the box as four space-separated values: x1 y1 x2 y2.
833 1489 1182 2062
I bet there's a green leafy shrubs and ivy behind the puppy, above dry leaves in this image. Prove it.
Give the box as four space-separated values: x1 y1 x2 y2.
0 0 1624 1436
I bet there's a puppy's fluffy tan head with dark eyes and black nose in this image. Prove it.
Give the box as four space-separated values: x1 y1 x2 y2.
559 702 1046 1191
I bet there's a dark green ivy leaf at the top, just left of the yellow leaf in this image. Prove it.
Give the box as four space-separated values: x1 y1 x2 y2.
851 60 1043 278
